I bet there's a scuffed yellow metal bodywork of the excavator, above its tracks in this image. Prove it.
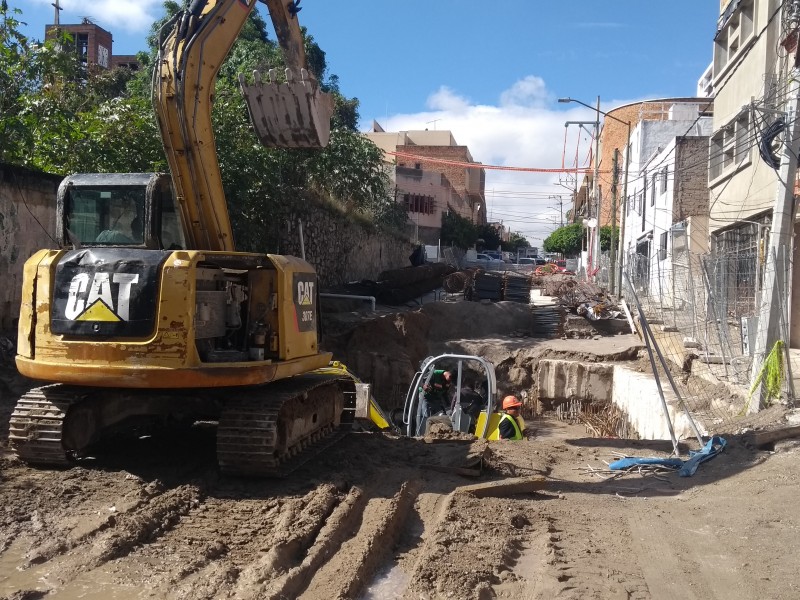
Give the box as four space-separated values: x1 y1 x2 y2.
17 250 331 388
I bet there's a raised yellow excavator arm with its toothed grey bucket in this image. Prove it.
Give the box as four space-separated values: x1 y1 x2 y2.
153 0 333 251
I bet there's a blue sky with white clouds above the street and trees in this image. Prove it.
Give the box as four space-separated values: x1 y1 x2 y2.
9 0 719 247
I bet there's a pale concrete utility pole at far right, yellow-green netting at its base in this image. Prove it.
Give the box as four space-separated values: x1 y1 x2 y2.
747 36 800 414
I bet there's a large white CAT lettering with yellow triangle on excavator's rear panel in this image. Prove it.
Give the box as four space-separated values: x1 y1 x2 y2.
64 273 139 322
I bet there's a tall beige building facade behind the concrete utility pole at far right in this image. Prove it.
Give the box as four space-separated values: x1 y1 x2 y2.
708 0 800 347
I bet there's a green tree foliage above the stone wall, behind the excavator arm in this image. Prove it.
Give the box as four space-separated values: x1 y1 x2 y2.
0 0 398 250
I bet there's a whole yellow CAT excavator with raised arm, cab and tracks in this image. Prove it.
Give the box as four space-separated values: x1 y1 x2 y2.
9 0 364 476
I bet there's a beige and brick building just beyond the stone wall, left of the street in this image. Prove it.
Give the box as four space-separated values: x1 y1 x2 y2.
364 122 486 244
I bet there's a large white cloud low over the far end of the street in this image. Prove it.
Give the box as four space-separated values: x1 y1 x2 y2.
370 76 590 247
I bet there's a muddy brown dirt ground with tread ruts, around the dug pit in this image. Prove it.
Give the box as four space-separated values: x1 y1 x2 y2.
0 303 800 600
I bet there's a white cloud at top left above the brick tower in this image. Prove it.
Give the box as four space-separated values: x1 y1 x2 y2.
33 0 163 33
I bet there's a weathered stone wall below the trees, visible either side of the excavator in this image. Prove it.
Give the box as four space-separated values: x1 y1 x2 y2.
0 164 414 332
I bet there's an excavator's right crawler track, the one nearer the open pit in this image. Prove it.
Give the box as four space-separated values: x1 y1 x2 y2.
217 374 354 477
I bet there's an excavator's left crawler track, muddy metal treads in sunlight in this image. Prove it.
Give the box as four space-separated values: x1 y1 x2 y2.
8 384 80 466
